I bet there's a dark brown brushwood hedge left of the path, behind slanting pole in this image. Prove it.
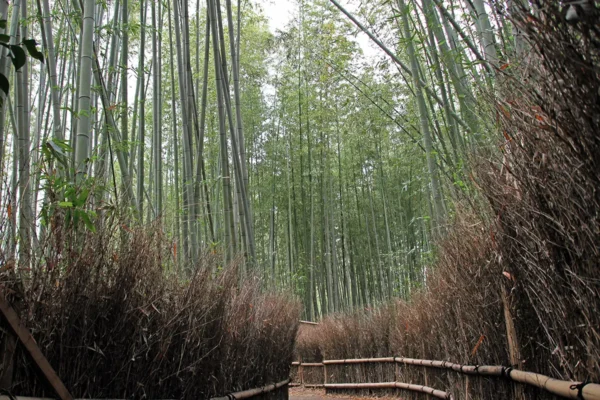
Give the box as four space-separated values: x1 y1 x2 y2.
0 226 300 399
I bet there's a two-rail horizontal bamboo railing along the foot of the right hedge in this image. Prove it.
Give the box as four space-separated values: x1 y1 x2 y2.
292 357 600 400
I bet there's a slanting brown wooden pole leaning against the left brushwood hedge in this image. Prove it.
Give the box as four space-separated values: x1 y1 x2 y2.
0 290 73 400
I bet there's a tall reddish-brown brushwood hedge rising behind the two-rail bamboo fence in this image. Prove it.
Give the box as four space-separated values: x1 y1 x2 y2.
296 2 600 398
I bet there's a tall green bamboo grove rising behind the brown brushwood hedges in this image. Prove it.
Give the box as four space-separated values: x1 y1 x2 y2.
0 0 582 320
